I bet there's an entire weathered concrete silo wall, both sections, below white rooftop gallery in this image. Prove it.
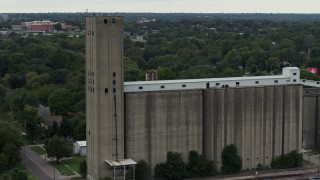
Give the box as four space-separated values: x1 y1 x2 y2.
125 85 302 170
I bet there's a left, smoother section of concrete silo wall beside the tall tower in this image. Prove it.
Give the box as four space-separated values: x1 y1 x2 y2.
125 90 203 168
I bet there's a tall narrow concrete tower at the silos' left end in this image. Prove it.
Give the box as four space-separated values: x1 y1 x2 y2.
86 16 124 179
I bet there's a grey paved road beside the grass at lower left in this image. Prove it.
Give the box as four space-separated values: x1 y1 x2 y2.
20 146 69 180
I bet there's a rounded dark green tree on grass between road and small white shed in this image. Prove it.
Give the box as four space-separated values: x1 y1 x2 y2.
46 135 70 162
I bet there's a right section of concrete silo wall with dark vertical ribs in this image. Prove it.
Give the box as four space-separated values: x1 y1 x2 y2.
203 85 302 169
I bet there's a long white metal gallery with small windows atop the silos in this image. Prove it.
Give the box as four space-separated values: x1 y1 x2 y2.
124 67 302 92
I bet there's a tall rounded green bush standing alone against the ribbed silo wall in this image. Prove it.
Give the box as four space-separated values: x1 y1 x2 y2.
221 144 242 174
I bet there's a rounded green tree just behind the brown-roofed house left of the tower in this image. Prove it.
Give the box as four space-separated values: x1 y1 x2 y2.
48 88 71 115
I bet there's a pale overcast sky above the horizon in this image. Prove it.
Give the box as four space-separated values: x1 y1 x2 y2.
0 0 320 13
